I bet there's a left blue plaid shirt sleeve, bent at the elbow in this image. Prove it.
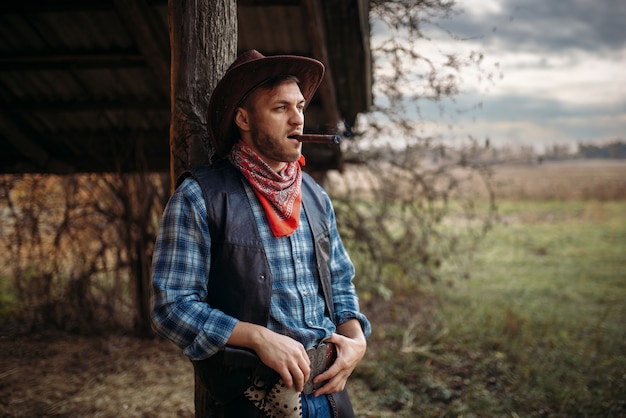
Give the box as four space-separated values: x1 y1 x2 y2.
152 179 237 360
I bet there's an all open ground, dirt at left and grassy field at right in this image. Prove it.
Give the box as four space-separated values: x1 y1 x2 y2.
0 161 626 418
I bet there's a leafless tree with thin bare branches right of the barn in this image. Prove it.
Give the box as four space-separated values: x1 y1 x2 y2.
331 0 495 296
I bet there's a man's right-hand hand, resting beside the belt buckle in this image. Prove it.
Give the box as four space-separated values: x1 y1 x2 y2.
313 319 367 396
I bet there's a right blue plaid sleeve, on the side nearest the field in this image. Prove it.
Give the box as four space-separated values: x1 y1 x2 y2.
323 188 372 338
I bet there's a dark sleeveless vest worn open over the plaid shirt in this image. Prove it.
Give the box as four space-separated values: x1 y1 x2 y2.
177 160 334 326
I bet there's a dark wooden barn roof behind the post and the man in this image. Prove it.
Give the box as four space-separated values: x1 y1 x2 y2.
0 0 371 173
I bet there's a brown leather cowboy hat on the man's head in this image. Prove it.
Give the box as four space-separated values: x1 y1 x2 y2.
208 49 324 157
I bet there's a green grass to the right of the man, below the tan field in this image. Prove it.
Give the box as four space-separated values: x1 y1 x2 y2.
352 201 626 417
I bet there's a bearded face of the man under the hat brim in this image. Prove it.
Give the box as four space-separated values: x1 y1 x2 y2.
242 81 305 171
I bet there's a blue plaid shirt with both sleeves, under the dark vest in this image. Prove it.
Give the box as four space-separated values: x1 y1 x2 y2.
152 178 371 360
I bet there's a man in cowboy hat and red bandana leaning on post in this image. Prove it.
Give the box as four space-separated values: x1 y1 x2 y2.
153 50 370 418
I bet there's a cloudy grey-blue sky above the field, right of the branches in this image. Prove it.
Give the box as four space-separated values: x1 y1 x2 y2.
366 0 626 150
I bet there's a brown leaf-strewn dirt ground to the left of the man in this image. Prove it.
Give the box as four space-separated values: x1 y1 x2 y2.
0 334 194 418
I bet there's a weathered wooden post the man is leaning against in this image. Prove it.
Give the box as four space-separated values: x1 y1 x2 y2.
168 0 237 417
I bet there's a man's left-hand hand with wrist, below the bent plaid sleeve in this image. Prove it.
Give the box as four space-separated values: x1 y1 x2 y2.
228 321 311 392
